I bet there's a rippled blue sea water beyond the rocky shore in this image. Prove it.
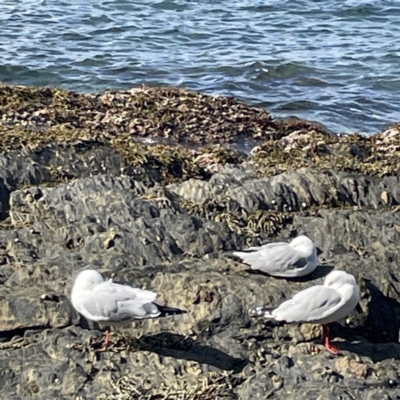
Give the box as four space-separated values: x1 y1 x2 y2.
0 0 400 133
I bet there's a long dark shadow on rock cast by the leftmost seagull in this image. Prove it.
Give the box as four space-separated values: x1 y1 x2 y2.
131 332 248 373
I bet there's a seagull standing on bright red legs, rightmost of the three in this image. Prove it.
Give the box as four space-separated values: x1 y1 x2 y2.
250 270 360 354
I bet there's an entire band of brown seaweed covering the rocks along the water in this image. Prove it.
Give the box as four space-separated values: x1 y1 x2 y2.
0 85 400 188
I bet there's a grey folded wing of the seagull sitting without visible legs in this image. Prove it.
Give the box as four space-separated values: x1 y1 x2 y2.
233 243 308 277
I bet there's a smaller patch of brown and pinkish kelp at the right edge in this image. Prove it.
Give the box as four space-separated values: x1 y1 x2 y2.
247 125 400 177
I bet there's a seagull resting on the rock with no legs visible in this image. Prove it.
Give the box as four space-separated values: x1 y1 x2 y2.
233 235 318 278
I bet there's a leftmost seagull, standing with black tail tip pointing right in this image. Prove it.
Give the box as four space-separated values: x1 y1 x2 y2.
71 269 186 351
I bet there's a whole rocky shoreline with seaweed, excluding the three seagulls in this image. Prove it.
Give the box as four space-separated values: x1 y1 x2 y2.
0 85 400 400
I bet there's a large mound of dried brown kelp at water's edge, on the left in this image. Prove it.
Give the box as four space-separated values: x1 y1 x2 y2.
0 85 279 144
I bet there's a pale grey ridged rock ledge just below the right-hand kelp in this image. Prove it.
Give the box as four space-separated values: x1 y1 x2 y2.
169 167 400 212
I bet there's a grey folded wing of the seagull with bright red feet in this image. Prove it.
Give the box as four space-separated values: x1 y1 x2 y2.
272 286 342 322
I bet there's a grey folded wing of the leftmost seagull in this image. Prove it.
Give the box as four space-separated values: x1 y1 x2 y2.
81 281 160 322
